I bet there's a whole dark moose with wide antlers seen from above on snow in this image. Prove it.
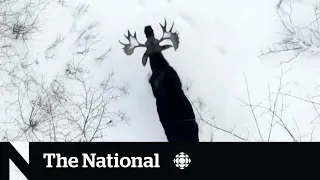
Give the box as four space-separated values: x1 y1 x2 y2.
119 19 199 142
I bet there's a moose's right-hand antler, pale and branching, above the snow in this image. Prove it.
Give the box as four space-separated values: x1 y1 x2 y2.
159 18 180 50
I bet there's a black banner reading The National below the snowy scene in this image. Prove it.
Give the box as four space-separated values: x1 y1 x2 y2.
0 143 320 180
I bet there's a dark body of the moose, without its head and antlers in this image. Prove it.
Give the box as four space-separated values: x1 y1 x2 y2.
149 53 199 142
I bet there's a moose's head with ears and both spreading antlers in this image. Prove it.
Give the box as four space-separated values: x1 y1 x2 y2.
119 19 180 66
